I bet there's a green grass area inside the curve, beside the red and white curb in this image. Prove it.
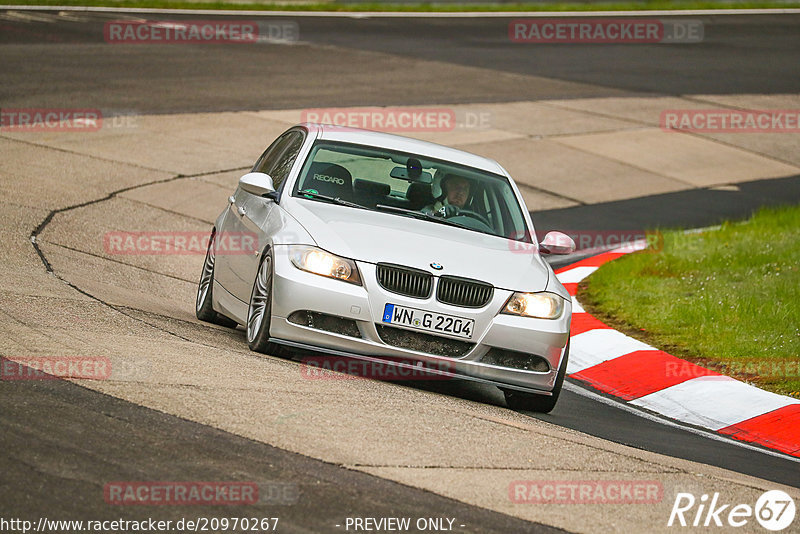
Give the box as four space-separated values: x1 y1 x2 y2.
578 206 800 397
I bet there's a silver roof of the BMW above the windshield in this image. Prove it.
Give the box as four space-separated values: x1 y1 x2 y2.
299 122 508 176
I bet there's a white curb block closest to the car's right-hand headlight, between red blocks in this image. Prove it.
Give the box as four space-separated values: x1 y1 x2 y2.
567 328 656 374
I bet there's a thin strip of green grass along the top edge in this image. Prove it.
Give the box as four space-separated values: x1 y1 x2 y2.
2 0 800 12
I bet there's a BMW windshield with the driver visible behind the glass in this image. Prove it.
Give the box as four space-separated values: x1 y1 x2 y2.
293 142 530 242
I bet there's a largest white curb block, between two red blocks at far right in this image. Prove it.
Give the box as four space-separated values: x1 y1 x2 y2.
632 374 800 430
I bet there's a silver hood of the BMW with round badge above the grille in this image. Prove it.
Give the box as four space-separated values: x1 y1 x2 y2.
291 199 550 291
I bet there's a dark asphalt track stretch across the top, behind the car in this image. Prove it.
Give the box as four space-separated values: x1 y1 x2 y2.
0 13 800 113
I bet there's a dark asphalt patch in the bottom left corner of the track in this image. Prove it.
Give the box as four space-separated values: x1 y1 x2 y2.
0 362 563 534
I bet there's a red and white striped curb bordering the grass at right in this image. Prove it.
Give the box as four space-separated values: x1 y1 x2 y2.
556 242 800 458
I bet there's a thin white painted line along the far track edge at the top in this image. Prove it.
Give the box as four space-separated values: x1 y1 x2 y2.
6 5 800 18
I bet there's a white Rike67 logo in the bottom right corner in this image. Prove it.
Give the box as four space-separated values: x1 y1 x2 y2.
667 490 796 532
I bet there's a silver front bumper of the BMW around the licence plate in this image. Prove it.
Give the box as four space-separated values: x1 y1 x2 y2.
270 246 571 394
